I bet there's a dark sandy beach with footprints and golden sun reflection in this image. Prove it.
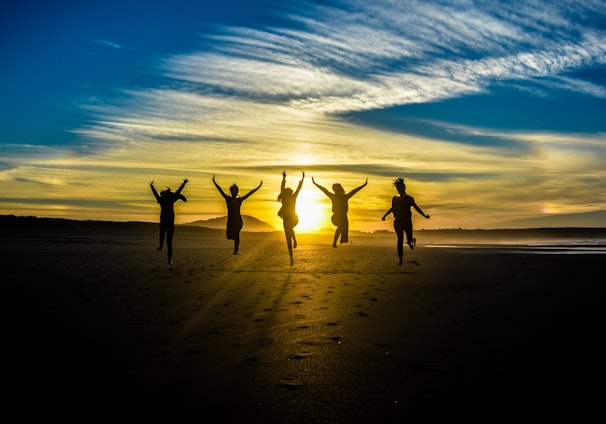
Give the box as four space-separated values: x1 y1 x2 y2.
0 219 606 423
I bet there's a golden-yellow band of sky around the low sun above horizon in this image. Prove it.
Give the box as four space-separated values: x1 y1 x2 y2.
0 126 606 231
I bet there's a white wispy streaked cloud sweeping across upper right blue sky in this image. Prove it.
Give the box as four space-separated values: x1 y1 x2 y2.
156 1 606 113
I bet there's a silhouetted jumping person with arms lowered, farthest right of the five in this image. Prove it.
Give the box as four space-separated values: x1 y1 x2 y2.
381 178 429 265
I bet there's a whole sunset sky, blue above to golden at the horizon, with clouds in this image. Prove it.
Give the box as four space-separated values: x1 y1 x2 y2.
0 0 606 231
